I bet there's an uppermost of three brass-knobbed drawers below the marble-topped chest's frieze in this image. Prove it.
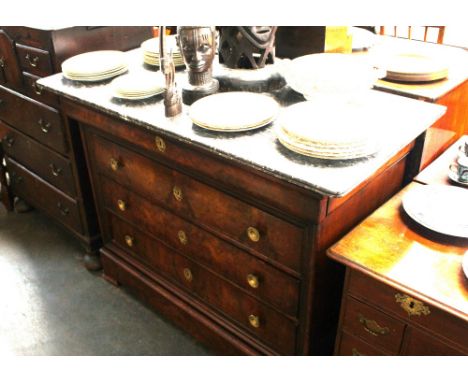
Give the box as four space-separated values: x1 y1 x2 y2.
90 136 303 270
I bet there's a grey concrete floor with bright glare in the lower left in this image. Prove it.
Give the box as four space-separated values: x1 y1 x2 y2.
0 203 211 356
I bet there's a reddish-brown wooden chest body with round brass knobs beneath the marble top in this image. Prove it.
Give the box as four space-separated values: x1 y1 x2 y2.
53 92 413 355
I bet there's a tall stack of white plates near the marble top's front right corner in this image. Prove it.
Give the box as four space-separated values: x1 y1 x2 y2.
276 101 378 160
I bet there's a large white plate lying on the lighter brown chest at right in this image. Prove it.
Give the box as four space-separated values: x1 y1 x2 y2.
402 185 468 238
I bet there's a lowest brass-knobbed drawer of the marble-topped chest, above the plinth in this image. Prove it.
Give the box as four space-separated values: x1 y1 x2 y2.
107 212 296 354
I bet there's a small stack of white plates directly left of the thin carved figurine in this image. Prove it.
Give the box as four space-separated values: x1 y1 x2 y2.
111 71 165 100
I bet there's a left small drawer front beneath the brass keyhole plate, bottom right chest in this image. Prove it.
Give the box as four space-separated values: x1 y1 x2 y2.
342 297 405 354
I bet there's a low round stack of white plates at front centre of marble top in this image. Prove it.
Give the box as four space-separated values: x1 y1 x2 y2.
189 92 279 132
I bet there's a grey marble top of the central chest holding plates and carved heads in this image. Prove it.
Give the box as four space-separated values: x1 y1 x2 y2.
38 49 445 197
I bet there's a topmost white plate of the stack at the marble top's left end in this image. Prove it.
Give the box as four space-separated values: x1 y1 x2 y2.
62 50 127 77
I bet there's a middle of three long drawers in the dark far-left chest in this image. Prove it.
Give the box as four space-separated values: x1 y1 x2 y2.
0 121 76 197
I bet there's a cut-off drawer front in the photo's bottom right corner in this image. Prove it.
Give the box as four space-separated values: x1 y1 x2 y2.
404 328 468 356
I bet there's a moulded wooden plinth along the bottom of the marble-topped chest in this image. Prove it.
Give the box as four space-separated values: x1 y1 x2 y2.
100 245 288 355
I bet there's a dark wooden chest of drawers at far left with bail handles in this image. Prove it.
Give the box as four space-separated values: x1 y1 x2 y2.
0 27 151 269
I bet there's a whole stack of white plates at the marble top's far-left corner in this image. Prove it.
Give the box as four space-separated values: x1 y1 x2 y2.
62 50 128 82
